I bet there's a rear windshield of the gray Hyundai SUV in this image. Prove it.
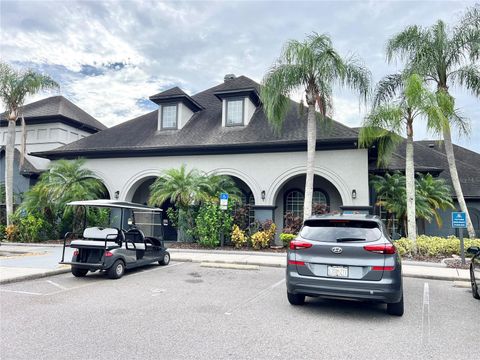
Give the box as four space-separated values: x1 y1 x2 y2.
300 220 382 242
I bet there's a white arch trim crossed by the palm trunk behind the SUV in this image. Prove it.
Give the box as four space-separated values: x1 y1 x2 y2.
266 166 351 205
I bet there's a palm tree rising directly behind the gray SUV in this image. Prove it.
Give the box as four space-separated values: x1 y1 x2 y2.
260 33 370 218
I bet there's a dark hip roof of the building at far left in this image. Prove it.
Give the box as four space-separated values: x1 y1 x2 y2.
0 95 107 132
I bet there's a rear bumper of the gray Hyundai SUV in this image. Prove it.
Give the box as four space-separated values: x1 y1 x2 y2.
286 266 403 303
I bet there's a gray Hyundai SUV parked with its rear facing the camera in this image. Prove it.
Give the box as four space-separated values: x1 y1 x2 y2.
287 214 403 316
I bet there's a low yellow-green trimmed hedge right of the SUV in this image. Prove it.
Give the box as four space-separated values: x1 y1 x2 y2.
394 235 480 257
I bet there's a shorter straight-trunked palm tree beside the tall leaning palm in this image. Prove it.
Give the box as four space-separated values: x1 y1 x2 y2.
359 74 448 241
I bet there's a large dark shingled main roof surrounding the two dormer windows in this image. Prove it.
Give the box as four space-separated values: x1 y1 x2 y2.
33 76 357 159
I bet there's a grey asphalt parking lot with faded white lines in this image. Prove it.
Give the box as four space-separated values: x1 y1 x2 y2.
0 263 480 360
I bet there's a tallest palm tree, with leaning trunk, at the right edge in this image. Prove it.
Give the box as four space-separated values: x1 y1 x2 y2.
387 4 480 238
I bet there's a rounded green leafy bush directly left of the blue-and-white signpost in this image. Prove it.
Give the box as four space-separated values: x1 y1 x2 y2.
195 202 233 247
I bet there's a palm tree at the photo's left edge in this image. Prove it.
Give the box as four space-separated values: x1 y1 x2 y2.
0 63 58 224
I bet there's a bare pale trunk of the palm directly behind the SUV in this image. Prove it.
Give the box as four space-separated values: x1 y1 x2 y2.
303 104 317 219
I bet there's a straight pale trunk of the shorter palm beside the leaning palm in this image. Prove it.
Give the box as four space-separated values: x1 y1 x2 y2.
405 132 417 242
